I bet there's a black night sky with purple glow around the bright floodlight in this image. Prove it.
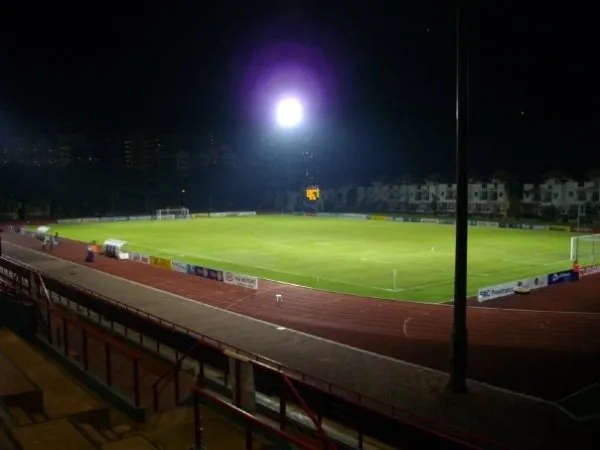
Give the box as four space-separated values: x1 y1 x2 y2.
0 0 600 178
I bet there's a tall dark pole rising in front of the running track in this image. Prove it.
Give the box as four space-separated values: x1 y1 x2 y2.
448 0 469 394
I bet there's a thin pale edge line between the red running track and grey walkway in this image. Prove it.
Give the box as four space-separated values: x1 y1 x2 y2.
5 241 587 422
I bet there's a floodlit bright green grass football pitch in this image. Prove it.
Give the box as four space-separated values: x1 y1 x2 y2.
45 216 570 302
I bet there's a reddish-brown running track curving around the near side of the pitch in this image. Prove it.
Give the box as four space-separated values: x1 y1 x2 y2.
7 235 600 400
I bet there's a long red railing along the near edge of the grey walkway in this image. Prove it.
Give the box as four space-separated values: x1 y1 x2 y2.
0 256 510 450
